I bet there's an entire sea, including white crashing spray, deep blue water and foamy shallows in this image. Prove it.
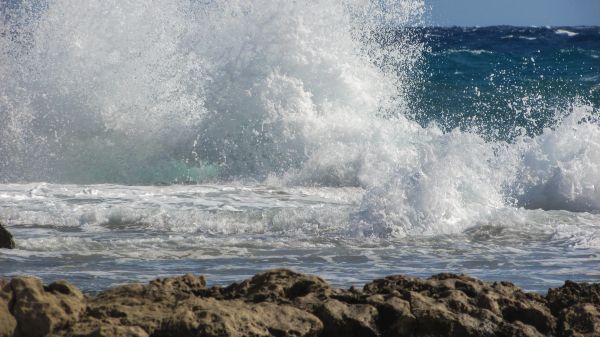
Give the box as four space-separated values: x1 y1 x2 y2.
0 0 600 292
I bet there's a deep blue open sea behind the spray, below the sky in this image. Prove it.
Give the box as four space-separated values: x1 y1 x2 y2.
414 26 600 139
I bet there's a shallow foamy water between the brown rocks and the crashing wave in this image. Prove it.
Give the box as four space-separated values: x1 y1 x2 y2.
0 184 600 292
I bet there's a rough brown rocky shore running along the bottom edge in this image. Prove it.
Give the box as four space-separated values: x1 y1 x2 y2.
0 269 600 337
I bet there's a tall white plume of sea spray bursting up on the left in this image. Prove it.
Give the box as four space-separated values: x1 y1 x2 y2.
1 0 422 184
